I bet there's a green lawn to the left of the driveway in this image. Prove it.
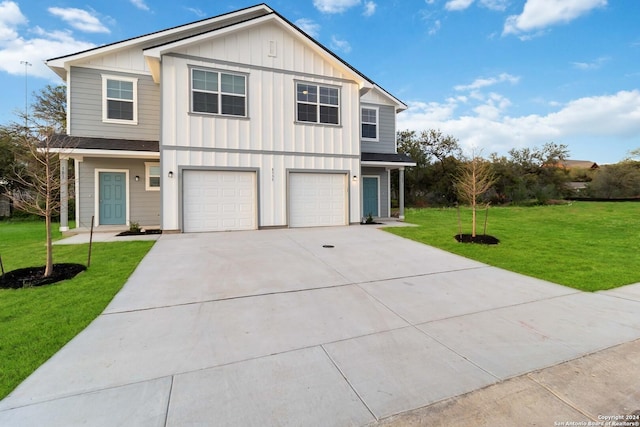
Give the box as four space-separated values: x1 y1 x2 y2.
0 221 154 399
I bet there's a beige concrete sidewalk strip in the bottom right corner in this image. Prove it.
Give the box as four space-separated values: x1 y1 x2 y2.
370 340 640 427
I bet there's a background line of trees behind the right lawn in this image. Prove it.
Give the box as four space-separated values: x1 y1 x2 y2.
393 129 640 207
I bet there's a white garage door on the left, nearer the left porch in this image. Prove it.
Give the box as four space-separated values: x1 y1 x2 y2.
182 170 257 232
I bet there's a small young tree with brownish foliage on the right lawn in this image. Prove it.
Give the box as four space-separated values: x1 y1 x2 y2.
455 152 496 238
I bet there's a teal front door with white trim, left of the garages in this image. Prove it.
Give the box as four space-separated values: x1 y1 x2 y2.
98 172 127 225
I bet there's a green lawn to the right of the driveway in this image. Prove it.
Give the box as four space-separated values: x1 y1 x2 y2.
387 202 640 291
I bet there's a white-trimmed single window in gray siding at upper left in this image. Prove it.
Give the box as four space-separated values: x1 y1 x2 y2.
102 75 138 124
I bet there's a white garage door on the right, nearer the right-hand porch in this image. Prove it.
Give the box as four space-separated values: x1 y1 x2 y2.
289 172 348 227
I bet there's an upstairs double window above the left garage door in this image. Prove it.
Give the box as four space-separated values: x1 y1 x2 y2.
191 68 247 117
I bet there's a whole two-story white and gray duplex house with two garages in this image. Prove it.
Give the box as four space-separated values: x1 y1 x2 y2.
47 4 415 232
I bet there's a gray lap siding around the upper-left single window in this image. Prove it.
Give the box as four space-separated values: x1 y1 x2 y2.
69 67 160 141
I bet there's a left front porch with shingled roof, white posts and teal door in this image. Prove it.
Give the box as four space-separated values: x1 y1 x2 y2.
54 135 162 232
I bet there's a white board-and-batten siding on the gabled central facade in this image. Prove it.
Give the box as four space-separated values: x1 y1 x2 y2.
160 18 360 230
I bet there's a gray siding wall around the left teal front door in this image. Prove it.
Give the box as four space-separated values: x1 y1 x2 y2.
76 157 160 228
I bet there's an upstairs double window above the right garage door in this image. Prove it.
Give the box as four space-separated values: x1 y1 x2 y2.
296 83 340 125
